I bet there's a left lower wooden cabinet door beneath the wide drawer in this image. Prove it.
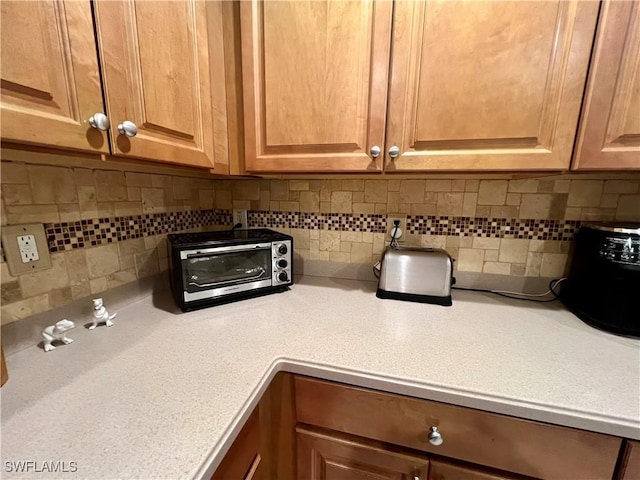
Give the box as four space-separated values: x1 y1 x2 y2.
296 427 429 480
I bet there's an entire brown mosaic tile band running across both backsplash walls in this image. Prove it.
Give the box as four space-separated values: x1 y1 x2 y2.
44 209 580 253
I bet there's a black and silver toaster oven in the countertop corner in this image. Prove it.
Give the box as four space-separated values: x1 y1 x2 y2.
167 228 293 311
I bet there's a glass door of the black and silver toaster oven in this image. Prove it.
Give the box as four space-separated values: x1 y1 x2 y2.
182 247 272 293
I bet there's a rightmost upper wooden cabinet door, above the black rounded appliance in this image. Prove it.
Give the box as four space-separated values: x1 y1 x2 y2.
573 1 640 170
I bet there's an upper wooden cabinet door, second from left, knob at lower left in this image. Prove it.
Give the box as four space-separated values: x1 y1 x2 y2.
95 0 226 168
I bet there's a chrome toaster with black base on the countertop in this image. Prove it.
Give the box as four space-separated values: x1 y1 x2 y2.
376 247 455 306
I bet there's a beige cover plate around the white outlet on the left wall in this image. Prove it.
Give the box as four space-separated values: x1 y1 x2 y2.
2 223 51 277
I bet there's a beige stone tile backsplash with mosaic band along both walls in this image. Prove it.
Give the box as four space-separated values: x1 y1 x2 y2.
0 161 640 324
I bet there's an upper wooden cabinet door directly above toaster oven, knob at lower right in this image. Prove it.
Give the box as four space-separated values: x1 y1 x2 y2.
240 0 392 172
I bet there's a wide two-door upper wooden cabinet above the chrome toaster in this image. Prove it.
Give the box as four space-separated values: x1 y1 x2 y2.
241 0 598 172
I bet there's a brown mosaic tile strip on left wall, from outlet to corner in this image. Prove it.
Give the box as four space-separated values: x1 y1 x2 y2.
44 210 233 253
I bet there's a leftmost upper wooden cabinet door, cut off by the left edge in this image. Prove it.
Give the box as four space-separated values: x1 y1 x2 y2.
0 0 109 152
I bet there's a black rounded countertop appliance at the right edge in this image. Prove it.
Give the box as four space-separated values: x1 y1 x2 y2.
560 223 640 337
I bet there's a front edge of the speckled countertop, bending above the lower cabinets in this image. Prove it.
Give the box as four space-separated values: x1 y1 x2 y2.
193 357 640 480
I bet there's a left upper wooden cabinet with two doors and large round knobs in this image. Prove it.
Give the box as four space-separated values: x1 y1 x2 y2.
2 0 228 170
